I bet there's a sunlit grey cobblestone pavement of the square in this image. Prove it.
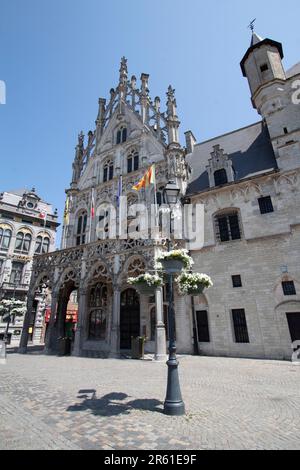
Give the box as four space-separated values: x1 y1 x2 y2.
0 354 300 450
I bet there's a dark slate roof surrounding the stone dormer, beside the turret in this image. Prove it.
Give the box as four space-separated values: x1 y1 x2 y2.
187 121 277 195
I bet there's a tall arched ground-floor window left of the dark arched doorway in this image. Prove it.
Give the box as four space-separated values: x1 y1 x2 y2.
89 283 107 341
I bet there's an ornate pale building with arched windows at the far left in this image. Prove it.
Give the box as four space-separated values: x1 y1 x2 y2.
0 189 58 346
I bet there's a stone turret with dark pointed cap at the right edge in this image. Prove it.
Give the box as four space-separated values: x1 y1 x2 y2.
241 32 300 170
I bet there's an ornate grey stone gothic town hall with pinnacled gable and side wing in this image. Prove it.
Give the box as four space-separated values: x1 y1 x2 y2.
21 33 300 359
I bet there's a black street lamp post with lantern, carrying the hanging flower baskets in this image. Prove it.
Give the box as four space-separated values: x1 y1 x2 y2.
164 181 185 416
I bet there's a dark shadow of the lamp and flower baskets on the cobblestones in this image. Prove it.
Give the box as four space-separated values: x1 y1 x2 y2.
67 389 163 416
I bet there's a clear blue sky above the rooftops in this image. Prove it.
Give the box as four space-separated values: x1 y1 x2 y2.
0 0 300 242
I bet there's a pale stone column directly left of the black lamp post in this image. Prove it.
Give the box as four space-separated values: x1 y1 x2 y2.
154 287 167 362
